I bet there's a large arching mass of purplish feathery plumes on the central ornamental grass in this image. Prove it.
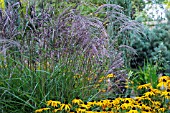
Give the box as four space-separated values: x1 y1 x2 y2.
56 4 143 93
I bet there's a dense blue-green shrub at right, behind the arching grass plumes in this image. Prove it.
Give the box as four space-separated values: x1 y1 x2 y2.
131 9 170 70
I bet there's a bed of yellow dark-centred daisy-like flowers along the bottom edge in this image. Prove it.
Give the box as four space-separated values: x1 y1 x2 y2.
35 76 170 113
